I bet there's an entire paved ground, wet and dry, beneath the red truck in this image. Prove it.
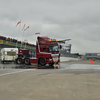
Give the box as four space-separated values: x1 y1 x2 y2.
0 61 100 100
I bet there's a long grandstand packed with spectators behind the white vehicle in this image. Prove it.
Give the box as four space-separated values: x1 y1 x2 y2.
0 36 36 54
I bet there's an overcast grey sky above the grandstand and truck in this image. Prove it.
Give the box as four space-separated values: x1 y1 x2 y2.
0 0 100 53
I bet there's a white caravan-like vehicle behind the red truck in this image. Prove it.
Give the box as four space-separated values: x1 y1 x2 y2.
1 48 18 63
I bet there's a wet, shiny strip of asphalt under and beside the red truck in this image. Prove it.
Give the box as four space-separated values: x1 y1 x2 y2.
0 62 100 73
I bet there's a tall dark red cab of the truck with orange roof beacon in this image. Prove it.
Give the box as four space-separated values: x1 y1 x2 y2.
36 37 60 66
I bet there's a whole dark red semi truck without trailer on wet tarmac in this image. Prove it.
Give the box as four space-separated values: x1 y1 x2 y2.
15 36 60 68
